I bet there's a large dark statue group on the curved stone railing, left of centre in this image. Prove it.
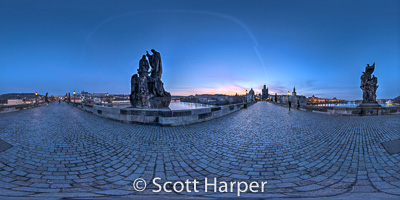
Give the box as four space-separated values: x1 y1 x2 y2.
130 49 171 108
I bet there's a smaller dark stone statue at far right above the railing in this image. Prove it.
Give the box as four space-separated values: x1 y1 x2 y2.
360 63 379 106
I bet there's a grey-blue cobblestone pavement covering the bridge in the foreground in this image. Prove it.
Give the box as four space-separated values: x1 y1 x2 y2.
0 102 400 198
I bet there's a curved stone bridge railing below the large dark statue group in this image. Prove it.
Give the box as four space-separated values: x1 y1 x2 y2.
72 103 255 126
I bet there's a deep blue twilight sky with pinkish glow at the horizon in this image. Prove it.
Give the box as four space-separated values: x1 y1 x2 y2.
0 0 400 100
